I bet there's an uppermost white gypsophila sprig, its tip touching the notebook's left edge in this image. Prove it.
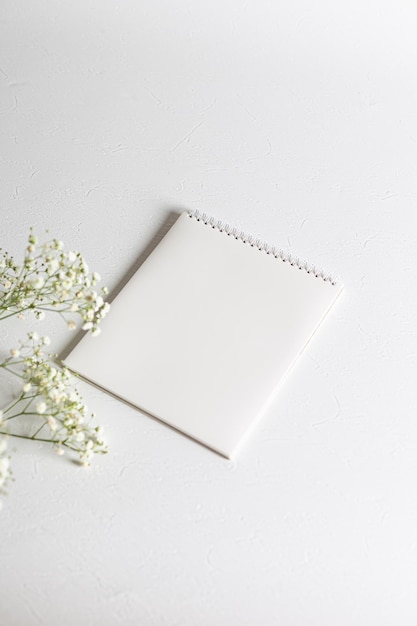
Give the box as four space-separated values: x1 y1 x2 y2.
0 231 110 335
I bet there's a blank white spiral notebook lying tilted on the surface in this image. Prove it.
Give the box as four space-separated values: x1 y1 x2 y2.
65 212 342 458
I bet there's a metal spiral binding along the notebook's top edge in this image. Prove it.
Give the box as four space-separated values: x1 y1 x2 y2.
187 210 336 285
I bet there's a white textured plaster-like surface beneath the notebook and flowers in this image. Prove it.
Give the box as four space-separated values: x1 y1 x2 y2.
0 0 417 626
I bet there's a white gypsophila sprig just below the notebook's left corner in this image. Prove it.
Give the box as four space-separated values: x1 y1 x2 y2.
3 332 107 465
